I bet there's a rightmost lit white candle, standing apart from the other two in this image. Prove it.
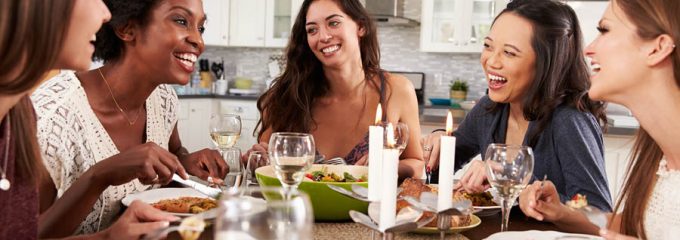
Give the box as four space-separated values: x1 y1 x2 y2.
437 111 456 211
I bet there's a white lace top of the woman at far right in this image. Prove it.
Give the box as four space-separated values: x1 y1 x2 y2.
644 159 680 240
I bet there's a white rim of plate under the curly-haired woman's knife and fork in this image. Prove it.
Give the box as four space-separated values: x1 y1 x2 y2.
121 188 215 217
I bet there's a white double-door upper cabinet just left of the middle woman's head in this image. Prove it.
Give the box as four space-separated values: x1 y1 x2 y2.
229 0 302 47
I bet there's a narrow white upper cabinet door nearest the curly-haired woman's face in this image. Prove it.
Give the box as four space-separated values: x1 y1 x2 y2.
203 0 229 46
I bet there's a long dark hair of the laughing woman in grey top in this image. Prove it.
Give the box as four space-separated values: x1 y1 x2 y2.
490 0 607 146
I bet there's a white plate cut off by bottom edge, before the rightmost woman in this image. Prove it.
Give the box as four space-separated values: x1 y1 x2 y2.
486 230 603 240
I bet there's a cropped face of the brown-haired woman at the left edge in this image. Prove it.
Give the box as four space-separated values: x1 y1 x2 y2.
55 0 111 71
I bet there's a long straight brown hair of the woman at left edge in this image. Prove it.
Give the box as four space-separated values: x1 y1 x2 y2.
0 0 74 184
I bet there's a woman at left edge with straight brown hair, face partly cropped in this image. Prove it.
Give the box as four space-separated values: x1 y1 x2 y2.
0 0 177 239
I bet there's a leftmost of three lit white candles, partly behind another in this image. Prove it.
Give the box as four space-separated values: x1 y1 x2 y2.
368 103 384 201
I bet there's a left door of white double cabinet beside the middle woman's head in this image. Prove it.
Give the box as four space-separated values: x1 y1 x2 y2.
229 0 266 47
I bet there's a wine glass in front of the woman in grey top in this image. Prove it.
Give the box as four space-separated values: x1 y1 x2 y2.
485 143 534 232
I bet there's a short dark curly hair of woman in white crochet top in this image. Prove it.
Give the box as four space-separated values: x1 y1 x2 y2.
92 0 161 62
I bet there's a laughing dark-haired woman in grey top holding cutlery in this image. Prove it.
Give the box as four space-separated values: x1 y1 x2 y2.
423 0 611 210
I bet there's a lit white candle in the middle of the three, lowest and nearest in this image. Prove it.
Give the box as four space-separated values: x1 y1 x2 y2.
379 123 399 231
